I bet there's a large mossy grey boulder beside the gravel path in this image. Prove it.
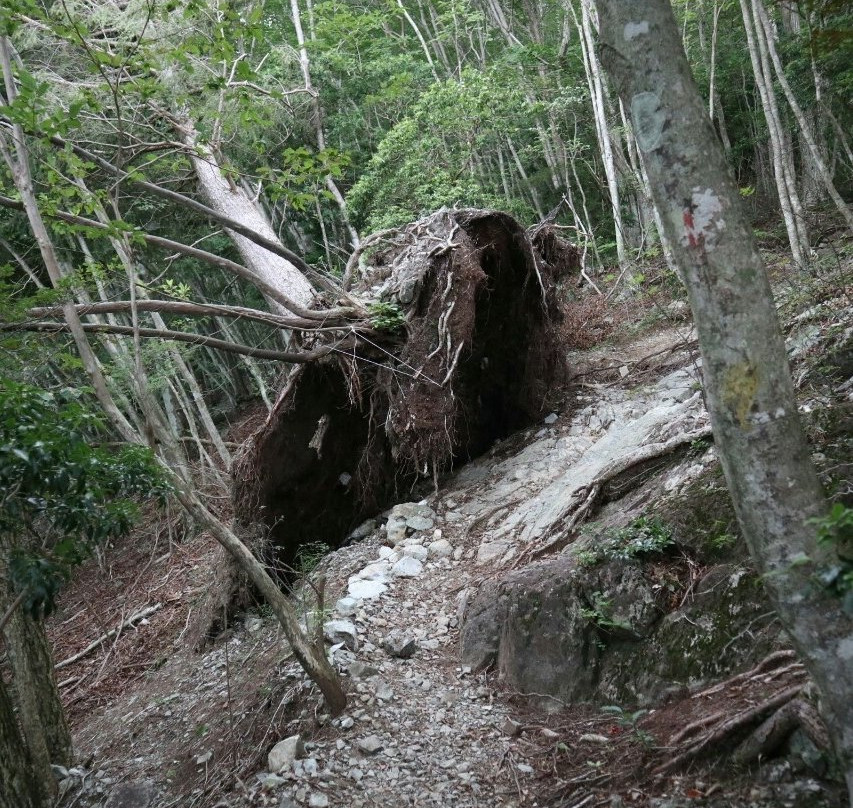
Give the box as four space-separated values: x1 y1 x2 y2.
462 556 776 704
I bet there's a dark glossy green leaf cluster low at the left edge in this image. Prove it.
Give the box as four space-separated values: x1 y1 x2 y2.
0 379 168 614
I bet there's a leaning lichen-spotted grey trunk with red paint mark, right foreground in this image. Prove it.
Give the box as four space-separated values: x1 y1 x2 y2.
598 0 853 796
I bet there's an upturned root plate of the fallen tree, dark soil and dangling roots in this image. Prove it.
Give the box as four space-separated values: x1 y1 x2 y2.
234 209 577 563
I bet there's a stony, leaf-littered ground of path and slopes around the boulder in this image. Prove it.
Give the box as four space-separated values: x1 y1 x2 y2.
50 235 853 808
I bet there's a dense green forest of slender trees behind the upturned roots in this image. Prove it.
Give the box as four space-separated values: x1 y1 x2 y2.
0 0 853 442
